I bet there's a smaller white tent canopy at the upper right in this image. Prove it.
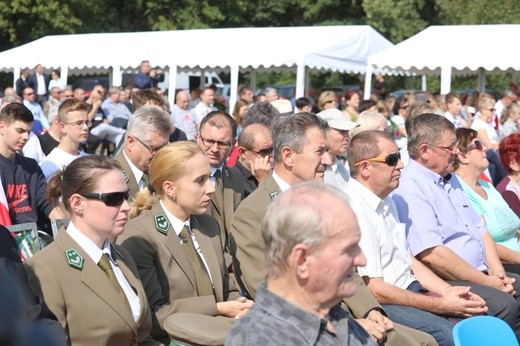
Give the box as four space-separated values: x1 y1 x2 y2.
365 24 520 95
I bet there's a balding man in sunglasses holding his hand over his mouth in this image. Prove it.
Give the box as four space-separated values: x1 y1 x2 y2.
231 124 273 198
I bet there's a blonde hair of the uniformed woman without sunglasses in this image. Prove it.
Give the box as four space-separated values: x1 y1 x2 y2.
129 141 204 219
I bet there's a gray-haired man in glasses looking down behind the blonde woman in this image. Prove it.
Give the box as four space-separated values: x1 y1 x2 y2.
114 106 173 200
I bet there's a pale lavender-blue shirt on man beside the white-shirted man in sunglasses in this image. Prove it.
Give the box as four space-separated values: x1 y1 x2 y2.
392 160 488 271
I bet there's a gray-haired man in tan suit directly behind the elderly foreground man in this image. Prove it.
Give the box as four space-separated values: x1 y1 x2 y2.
230 113 436 345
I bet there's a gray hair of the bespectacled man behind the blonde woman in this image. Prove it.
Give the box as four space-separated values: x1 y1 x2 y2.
126 106 174 141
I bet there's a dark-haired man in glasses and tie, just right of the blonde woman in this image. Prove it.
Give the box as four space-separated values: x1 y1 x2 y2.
197 111 244 251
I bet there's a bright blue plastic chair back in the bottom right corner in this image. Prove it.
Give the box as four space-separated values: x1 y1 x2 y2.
452 316 518 346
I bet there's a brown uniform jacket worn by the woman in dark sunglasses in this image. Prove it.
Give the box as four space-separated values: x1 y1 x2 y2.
26 228 153 346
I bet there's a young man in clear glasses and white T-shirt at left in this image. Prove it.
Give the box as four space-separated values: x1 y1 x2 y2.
40 99 92 181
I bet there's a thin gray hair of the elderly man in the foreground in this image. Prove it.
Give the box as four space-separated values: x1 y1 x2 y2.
262 181 350 277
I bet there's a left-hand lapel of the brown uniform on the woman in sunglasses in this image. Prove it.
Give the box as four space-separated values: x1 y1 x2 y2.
56 232 137 333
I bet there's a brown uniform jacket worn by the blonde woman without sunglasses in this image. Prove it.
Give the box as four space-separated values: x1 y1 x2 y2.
117 202 239 337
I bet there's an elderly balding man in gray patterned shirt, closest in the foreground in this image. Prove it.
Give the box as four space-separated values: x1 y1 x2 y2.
226 182 376 345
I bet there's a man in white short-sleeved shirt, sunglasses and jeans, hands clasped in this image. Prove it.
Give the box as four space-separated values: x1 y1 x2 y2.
347 130 487 345
